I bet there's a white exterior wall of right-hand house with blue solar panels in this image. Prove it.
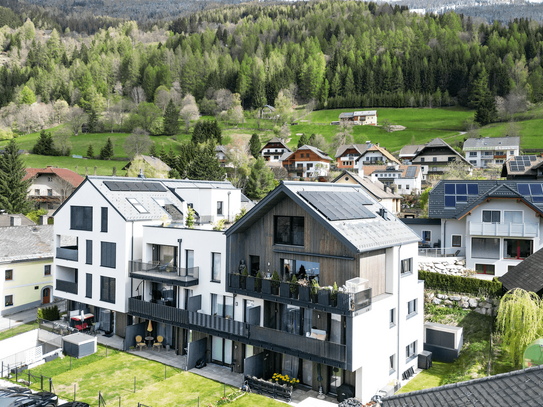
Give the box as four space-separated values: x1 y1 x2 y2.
460 199 543 277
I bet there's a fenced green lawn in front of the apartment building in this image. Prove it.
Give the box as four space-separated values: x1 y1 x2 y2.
19 346 281 407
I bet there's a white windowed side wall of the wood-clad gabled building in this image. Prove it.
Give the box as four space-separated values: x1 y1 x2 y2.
353 243 424 402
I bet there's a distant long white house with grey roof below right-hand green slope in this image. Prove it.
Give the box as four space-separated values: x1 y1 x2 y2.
463 136 520 168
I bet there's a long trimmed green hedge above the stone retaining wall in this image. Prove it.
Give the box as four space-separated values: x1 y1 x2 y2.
419 270 503 297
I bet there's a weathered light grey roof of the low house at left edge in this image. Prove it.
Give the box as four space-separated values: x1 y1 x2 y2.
0 225 54 262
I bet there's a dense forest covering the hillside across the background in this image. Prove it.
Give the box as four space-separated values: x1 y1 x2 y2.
0 0 543 118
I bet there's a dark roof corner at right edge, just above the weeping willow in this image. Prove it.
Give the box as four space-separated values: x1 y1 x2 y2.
500 249 543 294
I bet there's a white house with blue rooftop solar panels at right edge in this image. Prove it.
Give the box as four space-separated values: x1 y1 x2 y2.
428 180 543 278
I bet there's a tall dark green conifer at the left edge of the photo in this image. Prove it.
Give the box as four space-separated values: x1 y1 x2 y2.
0 139 32 213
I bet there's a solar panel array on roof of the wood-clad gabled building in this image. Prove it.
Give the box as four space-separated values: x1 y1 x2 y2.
298 191 376 221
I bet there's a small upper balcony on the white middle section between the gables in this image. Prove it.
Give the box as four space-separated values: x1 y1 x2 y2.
128 260 200 287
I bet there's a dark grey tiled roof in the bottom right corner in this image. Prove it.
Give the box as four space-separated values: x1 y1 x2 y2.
381 366 543 407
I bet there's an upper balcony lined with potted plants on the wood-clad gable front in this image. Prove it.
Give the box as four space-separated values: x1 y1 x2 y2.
226 274 372 316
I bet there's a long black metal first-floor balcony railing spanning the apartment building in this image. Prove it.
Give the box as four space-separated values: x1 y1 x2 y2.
128 298 347 368
